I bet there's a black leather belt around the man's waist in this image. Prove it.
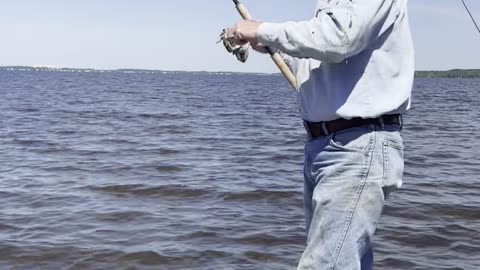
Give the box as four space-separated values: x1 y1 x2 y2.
304 114 403 138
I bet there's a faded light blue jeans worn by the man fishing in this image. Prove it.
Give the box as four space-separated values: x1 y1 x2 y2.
298 125 404 270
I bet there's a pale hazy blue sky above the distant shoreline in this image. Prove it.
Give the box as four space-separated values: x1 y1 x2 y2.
0 0 480 72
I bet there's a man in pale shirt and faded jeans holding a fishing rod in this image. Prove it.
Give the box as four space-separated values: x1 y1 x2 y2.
227 0 414 270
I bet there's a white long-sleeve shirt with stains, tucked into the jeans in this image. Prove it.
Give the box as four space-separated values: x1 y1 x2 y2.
257 0 414 122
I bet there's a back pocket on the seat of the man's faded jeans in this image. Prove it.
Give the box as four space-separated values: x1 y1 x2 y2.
383 140 405 195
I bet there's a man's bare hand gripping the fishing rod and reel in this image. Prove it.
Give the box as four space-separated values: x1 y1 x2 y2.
227 21 267 53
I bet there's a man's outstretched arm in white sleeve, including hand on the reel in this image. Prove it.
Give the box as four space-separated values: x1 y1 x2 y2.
231 0 400 63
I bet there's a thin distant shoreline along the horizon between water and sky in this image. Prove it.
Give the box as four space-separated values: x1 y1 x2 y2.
0 66 480 79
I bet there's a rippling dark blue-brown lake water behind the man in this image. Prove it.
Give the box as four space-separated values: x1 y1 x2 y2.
0 71 480 270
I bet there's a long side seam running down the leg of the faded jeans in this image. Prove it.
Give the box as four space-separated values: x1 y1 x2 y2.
328 131 376 270
